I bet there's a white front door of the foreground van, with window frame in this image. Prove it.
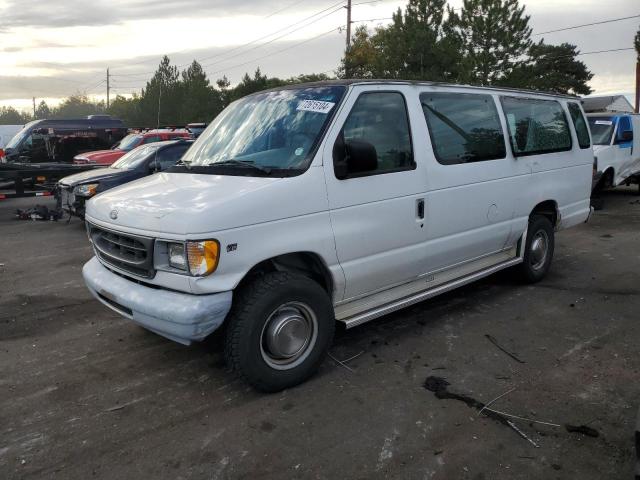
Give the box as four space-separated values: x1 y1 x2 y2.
323 86 426 299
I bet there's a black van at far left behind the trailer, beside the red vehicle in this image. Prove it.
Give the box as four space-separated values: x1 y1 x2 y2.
0 115 127 164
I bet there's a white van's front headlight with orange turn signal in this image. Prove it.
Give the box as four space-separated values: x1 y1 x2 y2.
167 240 220 277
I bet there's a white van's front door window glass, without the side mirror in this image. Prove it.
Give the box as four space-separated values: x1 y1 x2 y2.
342 92 415 174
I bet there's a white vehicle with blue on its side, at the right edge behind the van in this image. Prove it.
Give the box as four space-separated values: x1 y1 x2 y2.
587 113 640 191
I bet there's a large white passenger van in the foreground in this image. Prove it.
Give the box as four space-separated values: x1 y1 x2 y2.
83 81 593 391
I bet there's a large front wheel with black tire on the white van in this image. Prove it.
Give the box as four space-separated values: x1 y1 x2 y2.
225 272 335 392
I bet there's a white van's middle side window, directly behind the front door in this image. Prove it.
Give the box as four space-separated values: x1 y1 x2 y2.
420 92 506 165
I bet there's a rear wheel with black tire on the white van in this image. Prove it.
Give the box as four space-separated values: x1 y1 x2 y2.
518 215 555 283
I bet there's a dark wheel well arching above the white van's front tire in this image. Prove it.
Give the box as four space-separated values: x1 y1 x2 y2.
238 252 333 298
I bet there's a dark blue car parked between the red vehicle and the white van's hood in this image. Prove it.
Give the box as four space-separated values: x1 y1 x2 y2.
55 139 193 217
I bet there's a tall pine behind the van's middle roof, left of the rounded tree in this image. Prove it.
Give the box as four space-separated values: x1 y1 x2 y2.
444 0 531 85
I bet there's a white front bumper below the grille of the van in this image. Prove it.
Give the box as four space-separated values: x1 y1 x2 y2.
82 257 233 345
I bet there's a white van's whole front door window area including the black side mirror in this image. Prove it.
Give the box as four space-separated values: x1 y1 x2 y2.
334 92 415 178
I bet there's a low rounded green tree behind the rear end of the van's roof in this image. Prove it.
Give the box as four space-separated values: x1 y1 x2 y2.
500 40 593 95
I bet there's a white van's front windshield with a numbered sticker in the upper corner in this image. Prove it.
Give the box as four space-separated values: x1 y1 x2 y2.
182 86 345 175
